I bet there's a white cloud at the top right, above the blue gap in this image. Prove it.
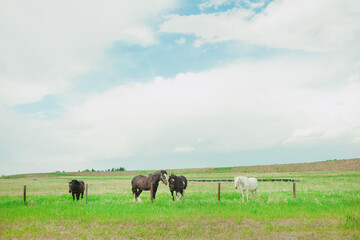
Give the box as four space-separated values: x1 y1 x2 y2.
160 0 360 52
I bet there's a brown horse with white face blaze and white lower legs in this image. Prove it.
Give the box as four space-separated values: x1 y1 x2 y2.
131 170 167 202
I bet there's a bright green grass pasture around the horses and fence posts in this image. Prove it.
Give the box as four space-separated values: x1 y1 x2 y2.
0 160 360 239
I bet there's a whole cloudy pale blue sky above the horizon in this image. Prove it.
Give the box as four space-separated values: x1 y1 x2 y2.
0 0 360 175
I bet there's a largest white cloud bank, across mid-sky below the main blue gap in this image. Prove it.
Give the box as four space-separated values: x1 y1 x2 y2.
56 54 360 155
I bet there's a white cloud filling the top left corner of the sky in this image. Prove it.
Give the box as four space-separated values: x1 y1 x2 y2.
0 0 174 105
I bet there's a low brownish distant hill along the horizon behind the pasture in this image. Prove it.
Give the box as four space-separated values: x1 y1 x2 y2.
3 158 360 178
